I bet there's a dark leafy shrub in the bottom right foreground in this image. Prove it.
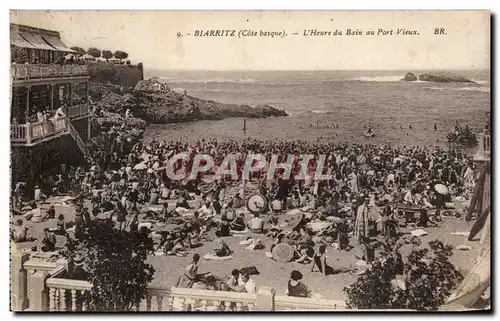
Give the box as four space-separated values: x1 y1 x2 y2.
344 238 462 310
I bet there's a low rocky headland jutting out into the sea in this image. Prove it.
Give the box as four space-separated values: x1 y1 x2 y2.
90 80 288 124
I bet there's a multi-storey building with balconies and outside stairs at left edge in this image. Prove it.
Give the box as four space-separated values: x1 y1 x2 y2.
10 24 90 192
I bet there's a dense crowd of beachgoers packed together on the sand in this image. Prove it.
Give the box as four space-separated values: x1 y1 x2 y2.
13 120 477 296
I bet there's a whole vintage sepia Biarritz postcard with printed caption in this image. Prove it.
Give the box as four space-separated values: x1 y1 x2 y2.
10 11 491 312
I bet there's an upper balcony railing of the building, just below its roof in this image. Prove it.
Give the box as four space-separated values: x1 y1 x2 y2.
11 64 89 80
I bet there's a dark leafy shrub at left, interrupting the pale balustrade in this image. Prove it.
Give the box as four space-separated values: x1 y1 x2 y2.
66 220 155 311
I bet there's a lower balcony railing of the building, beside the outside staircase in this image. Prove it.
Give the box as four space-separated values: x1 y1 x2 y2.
10 117 68 144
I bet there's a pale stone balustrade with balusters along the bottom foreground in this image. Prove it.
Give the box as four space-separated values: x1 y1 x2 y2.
11 246 346 311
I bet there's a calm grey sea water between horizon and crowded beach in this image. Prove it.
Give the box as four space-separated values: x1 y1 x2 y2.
145 70 491 147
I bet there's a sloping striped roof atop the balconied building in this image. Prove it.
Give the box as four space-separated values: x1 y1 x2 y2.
10 23 73 52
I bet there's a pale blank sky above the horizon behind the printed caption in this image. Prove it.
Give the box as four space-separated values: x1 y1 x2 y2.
11 11 490 70
